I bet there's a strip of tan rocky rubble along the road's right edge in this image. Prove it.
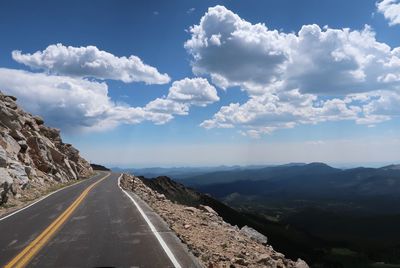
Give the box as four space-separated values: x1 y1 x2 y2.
121 174 308 268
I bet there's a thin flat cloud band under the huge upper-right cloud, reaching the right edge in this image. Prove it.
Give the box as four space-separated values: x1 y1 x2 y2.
200 85 400 138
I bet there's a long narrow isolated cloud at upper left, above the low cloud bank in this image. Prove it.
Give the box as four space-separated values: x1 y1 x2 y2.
12 44 170 84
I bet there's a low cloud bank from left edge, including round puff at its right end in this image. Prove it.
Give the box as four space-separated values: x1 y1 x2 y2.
0 68 218 132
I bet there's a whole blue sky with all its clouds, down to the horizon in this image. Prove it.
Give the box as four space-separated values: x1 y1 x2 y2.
0 0 400 167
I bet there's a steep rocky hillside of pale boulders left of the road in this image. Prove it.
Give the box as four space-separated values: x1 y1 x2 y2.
0 92 93 209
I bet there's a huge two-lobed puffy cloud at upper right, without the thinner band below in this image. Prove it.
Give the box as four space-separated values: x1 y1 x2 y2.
185 6 400 95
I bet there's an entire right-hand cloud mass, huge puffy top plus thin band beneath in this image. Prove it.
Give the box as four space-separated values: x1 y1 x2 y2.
189 6 400 137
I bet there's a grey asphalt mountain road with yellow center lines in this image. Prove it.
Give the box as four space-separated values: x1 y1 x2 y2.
0 173 198 267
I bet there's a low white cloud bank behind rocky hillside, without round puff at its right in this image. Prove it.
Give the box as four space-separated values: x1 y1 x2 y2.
0 68 188 132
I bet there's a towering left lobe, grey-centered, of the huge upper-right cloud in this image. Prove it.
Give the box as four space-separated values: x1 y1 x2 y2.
185 6 288 94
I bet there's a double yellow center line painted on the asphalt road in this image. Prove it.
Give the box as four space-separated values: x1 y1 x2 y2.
5 173 111 268
